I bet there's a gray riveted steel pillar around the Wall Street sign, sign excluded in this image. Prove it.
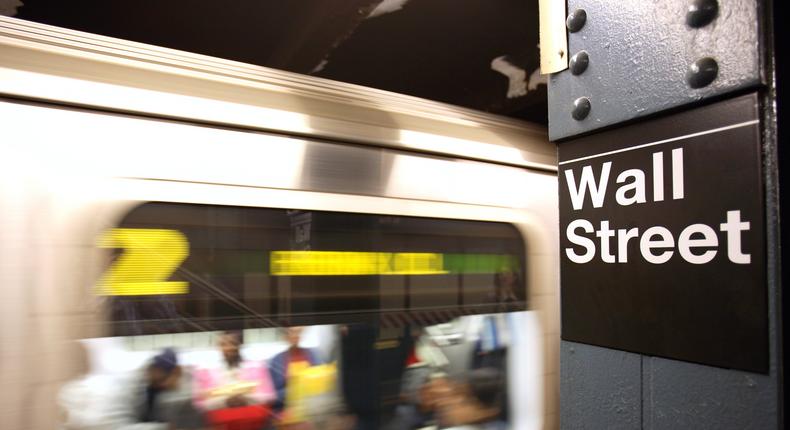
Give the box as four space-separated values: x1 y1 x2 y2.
549 0 790 429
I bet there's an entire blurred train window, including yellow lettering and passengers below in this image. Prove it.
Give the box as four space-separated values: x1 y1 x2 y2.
60 203 539 429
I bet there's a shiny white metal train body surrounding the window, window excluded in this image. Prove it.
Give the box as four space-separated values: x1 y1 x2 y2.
0 17 559 429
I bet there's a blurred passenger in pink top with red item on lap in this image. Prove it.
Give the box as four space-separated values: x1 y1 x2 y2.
195 331 275 428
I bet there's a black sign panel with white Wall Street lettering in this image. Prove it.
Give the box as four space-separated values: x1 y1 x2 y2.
559 94 768 372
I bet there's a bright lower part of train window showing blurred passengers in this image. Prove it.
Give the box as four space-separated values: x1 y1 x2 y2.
61 317 524 429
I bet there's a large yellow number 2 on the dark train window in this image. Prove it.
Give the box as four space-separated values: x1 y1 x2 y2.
96 228 189 296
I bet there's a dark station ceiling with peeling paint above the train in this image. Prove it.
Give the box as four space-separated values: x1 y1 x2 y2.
0 0 547 124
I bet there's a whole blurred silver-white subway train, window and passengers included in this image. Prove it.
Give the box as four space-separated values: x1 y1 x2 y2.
0 17 559 429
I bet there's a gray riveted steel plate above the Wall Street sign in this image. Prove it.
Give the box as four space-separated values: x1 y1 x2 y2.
549 0 761 140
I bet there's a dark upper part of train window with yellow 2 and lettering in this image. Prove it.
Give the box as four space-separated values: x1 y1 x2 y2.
97 203 526 335
